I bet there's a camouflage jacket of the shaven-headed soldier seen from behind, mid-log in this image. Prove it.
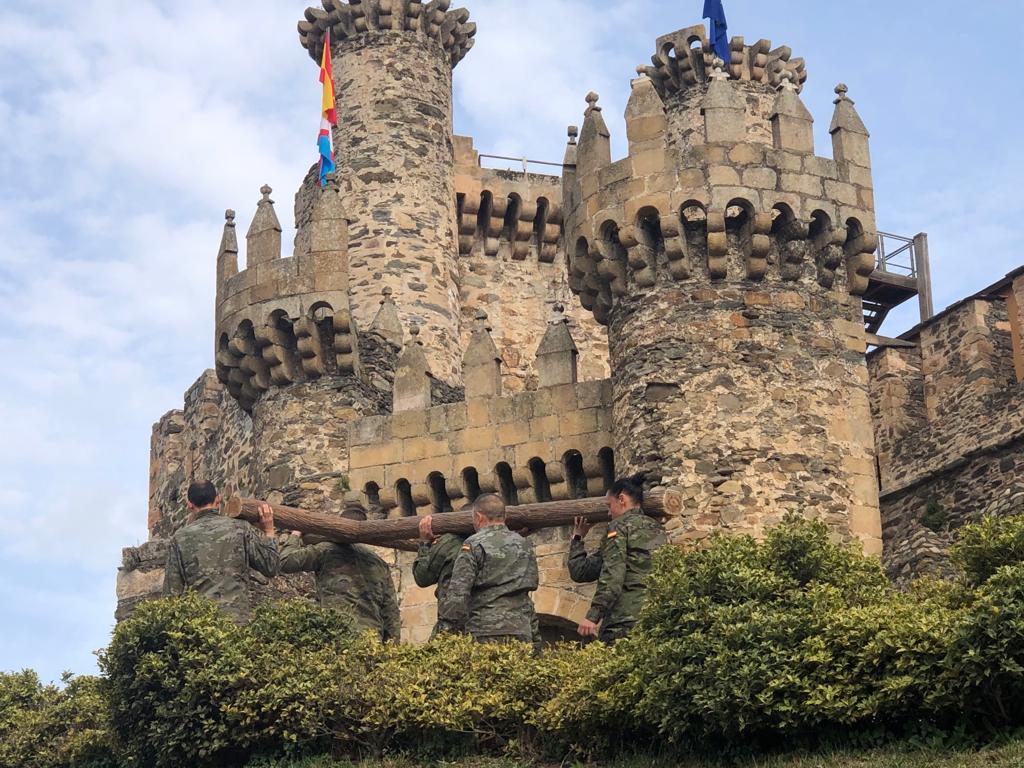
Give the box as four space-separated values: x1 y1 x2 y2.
437 525 538 642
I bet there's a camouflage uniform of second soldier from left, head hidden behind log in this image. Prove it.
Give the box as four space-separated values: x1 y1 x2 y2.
281 536 401 642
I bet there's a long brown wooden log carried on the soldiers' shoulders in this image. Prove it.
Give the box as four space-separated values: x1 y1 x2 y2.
227 489 683 546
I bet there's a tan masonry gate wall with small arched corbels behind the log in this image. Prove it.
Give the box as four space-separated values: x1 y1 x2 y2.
349 380 614 642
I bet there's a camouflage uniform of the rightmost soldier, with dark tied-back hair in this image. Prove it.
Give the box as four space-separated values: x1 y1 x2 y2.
568 509 667 643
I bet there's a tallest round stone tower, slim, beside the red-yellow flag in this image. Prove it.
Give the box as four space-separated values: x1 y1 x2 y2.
299 0 476 382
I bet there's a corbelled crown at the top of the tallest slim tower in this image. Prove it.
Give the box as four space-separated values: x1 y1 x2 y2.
298 0 476 68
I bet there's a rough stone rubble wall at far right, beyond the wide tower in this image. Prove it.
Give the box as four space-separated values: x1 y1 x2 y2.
868 279 1024 583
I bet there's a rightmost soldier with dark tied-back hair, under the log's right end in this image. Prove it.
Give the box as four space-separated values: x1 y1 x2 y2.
568 475 666 643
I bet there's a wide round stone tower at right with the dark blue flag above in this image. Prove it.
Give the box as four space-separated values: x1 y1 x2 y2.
564 26 881 552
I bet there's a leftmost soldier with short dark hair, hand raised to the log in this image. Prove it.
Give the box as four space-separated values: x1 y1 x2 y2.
164 481 279 624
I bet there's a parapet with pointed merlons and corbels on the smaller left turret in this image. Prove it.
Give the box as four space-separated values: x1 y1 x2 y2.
216 179 358 411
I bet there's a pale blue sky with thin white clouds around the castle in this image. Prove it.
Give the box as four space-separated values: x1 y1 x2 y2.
0 0 1024 680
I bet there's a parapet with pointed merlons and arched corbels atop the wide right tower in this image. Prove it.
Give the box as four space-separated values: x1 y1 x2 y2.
563 47 877 324
